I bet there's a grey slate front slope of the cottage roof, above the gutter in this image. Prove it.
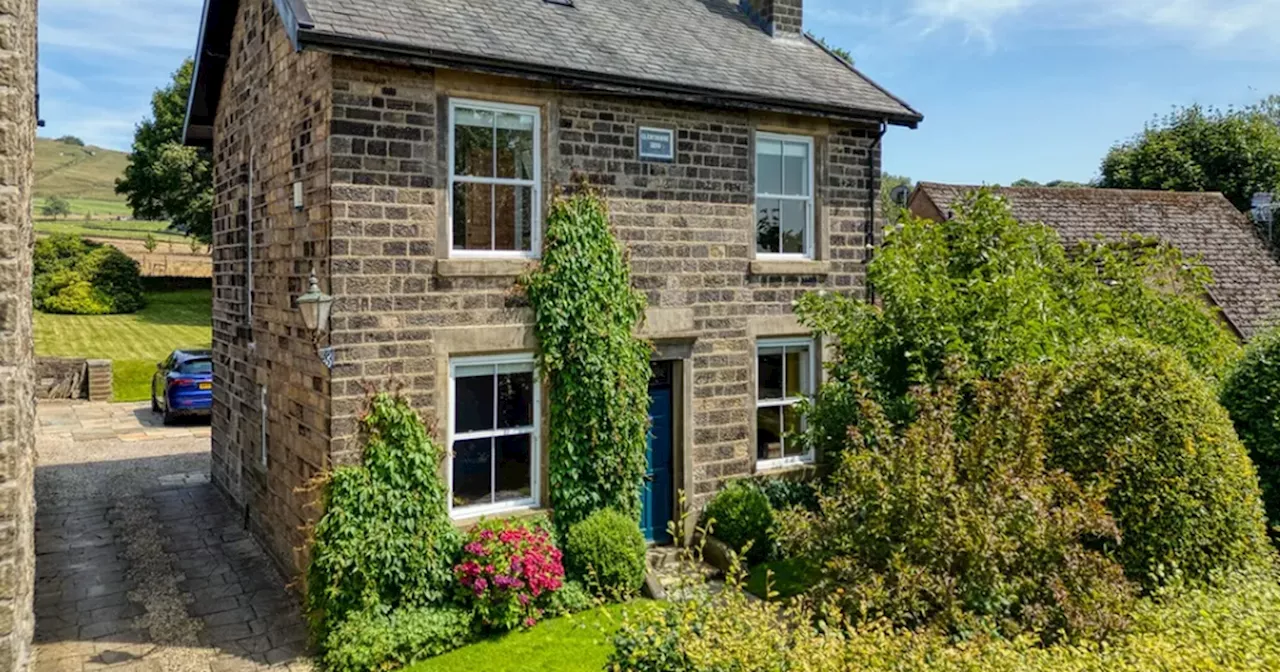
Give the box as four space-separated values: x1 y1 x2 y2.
296 0 920 124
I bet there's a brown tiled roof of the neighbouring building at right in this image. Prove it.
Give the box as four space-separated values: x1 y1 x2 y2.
911 182 1280 338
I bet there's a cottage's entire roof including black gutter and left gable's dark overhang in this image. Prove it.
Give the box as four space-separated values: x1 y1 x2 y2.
188 0 923 142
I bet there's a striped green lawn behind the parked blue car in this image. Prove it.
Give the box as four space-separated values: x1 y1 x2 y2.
35 289 212 402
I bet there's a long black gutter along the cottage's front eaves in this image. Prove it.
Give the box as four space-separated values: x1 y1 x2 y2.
298 27 924 128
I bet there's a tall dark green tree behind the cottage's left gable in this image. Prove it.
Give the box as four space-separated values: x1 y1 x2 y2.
115 59 214 242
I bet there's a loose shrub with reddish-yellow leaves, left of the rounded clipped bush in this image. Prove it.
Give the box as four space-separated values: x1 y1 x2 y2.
778 374 1133 641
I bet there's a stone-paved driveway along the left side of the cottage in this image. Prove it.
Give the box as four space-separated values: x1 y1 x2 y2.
35 402 312 672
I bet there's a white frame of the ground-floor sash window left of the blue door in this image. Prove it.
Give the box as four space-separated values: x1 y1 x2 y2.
445 353 543 520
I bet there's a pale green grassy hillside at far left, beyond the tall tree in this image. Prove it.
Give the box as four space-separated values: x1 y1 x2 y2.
35 138 129 200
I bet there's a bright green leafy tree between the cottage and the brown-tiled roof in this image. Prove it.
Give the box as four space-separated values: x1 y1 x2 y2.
797 189 1239 430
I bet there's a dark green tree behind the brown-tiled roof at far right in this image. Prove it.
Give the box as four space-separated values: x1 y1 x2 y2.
1101 97 1280 210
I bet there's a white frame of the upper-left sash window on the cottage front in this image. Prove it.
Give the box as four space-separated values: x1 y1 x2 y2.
445 99 543 259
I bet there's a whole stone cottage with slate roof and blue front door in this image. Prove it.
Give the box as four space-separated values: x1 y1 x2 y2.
186 0 922 568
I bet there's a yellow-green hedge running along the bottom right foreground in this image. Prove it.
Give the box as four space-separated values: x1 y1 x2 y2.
607 572 1280 672
